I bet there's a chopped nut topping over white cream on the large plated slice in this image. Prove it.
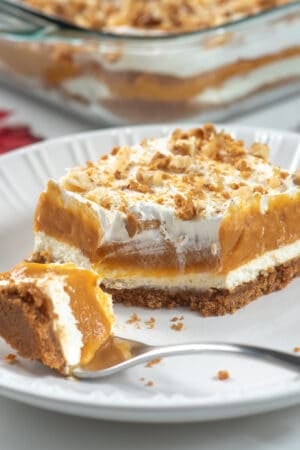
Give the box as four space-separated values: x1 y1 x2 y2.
59 124 300 221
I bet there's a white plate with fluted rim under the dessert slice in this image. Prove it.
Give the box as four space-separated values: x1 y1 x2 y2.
0 125 300 422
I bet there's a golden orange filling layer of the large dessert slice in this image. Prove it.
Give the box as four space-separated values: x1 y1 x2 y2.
35 184 300 276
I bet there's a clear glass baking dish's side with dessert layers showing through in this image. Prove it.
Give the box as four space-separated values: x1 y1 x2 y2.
0 0 300 124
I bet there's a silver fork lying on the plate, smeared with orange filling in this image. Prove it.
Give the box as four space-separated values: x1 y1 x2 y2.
72 336 300 379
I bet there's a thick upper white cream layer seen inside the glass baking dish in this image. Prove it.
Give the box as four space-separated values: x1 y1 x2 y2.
87 19 300 77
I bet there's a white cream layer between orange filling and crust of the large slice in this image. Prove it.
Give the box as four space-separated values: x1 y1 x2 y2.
35 233 300 290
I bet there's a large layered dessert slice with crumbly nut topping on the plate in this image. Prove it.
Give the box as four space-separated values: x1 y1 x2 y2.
33 124 300 315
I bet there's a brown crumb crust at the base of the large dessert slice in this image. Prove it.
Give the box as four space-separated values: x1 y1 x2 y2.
101 258 300 317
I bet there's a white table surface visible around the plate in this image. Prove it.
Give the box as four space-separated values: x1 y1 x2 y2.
0 87 300 450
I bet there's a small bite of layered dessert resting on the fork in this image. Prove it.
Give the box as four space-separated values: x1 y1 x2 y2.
0 263 113 375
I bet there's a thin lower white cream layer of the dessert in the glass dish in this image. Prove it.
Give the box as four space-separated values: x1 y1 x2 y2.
62 56 300 105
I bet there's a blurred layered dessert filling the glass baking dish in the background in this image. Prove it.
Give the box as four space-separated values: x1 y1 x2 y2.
0 0 300 123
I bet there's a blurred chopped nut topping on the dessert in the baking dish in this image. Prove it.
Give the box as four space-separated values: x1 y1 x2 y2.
24 0 291 33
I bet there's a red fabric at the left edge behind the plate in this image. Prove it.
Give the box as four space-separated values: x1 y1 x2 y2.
0 110 42 154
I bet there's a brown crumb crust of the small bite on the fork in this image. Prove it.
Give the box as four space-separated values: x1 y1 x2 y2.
0 285 65 373
